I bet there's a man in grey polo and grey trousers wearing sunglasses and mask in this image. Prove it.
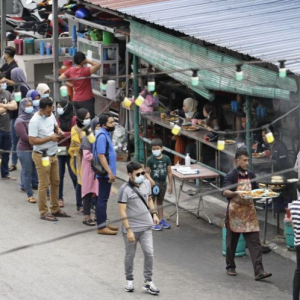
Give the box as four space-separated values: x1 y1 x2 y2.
118 162 159 295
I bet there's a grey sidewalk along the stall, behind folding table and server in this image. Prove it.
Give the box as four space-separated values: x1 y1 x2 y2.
117 162 296 262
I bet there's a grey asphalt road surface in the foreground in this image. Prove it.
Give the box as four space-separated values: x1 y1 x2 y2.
0 176 295 300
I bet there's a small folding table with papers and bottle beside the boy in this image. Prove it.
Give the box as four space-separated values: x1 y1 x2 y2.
168 165 219 226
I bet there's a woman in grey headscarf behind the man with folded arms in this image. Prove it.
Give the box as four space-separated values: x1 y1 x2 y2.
7 68 30 172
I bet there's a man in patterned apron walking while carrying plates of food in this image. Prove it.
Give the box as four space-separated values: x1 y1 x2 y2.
223 148 272 281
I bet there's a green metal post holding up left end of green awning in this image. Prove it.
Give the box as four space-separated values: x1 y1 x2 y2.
133 55 140 161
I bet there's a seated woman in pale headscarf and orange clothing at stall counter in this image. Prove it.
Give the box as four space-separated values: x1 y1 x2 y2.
171 98 200 165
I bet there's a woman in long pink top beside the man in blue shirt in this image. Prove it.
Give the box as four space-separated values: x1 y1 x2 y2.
80 117 100 226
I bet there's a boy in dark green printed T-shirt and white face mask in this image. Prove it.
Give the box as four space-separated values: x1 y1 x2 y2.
146 139 173 231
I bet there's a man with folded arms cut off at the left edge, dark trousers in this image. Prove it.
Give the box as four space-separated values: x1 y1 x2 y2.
0 83 18 180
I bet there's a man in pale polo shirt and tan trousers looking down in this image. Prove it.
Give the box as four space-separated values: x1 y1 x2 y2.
28 98 70 221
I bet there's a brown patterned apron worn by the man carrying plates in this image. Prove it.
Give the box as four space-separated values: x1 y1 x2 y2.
228 178 259 233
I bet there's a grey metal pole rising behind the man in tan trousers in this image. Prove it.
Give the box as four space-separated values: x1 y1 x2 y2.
52 0 59 105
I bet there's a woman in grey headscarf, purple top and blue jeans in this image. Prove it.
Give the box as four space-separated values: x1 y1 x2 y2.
15 98 38 203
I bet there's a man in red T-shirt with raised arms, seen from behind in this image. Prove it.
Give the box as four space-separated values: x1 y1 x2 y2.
59 52 101 118
